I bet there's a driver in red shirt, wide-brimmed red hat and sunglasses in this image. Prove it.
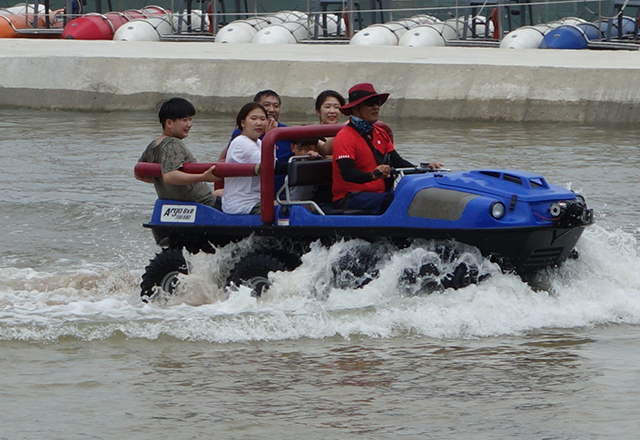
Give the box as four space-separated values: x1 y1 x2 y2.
332 83 442 215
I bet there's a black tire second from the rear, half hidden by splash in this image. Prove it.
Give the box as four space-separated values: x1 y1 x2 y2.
229 254 287 298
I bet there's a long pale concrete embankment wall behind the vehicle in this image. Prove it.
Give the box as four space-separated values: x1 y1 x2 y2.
0 39 640 122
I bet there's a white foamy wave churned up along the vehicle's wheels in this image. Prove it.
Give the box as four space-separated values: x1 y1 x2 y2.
0 225 640 343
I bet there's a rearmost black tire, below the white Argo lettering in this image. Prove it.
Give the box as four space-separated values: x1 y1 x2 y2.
140 248 189 302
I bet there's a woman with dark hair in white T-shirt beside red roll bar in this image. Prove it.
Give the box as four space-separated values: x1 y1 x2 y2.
222 102 269 214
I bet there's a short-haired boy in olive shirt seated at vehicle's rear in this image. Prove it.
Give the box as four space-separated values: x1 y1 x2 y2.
136 98 220 208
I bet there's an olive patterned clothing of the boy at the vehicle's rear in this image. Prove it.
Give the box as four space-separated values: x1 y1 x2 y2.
138 137 215 206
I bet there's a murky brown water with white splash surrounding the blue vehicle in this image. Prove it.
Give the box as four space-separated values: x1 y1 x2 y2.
0 109 640 440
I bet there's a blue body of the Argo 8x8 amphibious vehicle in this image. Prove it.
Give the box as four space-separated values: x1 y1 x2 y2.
142 126 593 295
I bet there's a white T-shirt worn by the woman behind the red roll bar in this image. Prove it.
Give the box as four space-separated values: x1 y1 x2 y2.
222 134 262 214
